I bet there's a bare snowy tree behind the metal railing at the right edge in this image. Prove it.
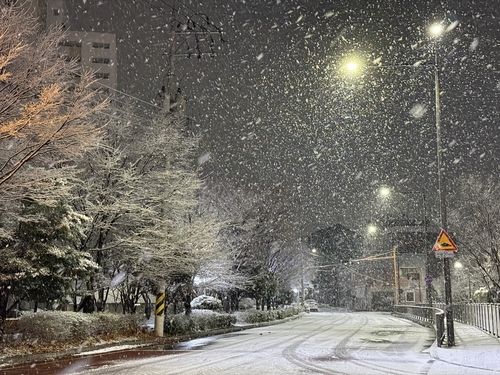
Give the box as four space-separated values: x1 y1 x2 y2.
450 176 500 302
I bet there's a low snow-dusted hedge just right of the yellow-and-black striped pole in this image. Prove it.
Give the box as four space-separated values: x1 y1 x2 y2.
164 310 236 335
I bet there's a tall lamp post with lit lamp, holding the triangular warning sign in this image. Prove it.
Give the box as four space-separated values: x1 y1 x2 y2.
430 24 455 346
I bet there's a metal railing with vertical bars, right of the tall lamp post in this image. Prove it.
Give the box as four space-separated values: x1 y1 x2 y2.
435 303 500 337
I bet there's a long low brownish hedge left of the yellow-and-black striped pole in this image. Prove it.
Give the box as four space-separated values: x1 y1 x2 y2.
19 311 142 342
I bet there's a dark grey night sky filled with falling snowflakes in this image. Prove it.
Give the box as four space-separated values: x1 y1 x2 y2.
69 0 500 238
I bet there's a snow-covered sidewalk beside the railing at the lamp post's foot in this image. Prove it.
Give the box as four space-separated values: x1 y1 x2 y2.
429 322 500 373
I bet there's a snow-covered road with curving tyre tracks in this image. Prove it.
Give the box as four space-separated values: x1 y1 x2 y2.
75 312 491 375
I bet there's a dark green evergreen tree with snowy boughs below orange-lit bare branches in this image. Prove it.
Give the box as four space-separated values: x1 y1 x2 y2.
1 194 97 312
